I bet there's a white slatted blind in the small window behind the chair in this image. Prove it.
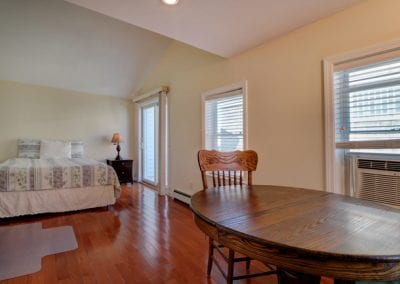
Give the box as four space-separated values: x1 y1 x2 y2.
204 88 244 151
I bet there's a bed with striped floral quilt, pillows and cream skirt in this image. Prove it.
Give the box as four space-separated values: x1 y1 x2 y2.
0 140 120 218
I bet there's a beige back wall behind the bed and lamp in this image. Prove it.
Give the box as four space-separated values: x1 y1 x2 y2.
0 81 133 162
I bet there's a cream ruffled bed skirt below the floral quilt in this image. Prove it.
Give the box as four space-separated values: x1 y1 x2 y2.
0 185 115 218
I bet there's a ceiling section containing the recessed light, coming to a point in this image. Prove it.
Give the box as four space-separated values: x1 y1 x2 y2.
67 0 362 57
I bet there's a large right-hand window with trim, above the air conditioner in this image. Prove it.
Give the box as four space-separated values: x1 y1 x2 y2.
324 41 400 193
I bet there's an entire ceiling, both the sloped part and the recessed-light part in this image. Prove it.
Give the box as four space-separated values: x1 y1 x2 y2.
0 0 360 98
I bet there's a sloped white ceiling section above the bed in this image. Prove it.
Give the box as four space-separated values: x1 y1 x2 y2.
0 0 171 97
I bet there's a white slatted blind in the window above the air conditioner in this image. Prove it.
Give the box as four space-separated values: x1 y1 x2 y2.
334 57 400 148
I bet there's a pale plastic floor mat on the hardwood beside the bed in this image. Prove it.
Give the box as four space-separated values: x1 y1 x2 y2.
0 223 78 280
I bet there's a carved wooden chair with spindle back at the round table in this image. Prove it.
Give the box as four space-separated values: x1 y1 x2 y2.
198 150 276 283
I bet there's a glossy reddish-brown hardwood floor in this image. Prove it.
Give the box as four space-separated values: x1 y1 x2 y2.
0 184 330 284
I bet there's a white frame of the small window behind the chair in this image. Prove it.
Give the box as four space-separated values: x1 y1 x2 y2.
201 81 248 150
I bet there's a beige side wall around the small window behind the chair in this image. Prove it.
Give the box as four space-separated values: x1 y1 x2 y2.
141 0 400 195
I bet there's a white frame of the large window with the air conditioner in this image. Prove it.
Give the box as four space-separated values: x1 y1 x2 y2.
323 40 400 194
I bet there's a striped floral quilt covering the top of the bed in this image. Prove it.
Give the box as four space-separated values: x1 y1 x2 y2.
0 158 120 197
